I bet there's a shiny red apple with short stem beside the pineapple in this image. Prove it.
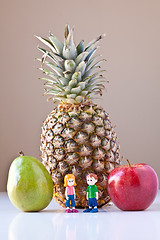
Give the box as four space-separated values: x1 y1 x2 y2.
107 160 159 211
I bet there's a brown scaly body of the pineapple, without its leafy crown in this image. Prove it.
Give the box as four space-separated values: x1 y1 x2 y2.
40 101 121 208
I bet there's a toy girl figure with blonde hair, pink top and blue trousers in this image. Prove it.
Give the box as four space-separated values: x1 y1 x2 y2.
64 174 78 213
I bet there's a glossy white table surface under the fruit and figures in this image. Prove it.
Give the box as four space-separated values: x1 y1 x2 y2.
0 192 160 240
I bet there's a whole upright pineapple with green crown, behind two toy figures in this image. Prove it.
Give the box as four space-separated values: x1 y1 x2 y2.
36 25 121 208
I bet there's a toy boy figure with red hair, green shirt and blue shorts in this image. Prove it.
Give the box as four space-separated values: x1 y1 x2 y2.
83 173 98 213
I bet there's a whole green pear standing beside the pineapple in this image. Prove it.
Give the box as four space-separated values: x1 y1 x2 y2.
7 152 53 212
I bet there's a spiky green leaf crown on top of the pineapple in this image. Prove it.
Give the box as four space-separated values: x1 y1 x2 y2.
36 25 106 104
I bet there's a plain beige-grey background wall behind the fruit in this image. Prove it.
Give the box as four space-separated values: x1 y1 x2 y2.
0 0 160 191
